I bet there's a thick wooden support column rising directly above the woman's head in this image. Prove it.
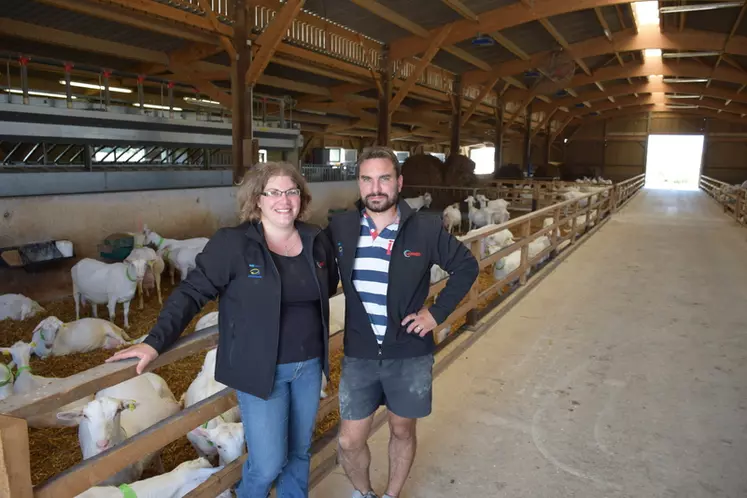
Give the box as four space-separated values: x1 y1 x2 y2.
231 0 253 184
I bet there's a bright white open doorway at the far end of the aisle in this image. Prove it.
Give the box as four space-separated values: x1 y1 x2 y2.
646 135 704 190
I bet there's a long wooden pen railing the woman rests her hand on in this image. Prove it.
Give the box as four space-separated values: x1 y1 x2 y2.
0 178 643 498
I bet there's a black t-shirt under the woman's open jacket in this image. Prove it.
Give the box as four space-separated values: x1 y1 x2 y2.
271 253 324 364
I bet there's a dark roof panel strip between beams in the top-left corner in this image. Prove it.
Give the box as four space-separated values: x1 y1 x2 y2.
2 0 185 52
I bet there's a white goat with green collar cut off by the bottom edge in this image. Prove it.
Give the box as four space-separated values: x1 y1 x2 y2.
76 458 231 498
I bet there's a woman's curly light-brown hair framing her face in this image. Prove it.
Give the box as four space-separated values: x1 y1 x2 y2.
236 162 311 223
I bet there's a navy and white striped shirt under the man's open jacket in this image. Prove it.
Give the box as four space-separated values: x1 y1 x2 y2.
353 208 400 345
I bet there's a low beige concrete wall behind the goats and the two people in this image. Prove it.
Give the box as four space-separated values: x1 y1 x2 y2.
0 182 358 257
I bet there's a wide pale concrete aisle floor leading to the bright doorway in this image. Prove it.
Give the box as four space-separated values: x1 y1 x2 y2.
310 190 747 498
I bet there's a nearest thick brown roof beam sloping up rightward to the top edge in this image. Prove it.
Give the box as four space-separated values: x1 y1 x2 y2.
388 0 629 59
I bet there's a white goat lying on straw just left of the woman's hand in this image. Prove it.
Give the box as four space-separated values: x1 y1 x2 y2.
31 316 139 358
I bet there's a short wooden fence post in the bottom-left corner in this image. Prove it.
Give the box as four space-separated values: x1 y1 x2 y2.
0 415 34 498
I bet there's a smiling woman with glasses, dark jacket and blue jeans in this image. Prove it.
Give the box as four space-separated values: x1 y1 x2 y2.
107 162 338 498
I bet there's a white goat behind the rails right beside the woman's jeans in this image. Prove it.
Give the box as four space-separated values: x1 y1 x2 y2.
180 348 241 457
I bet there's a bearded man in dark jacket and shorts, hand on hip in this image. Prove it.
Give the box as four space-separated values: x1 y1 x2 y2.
327 147 479 498
